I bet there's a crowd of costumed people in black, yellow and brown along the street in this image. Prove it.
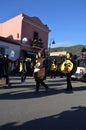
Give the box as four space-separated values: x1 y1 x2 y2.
0 50 76 93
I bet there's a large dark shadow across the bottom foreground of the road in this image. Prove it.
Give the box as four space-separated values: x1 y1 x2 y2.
0 106 86 130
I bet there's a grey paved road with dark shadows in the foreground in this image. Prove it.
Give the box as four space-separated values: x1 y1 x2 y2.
0 77 86 130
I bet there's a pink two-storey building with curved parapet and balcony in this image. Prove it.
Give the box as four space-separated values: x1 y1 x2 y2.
0 14 50 57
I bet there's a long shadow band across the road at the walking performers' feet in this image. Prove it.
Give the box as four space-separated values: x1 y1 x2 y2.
0 85 86 100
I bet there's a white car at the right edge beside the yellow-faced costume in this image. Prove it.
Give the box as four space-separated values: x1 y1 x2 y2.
71 58 86 80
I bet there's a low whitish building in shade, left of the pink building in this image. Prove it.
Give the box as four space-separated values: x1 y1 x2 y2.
0 37 20 61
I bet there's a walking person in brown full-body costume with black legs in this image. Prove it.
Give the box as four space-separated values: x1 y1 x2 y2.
34 51 48 93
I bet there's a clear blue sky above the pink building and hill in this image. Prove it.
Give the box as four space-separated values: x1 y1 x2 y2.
0 0 86 47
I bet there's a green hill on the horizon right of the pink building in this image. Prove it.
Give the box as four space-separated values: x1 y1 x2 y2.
51 45 86 56
